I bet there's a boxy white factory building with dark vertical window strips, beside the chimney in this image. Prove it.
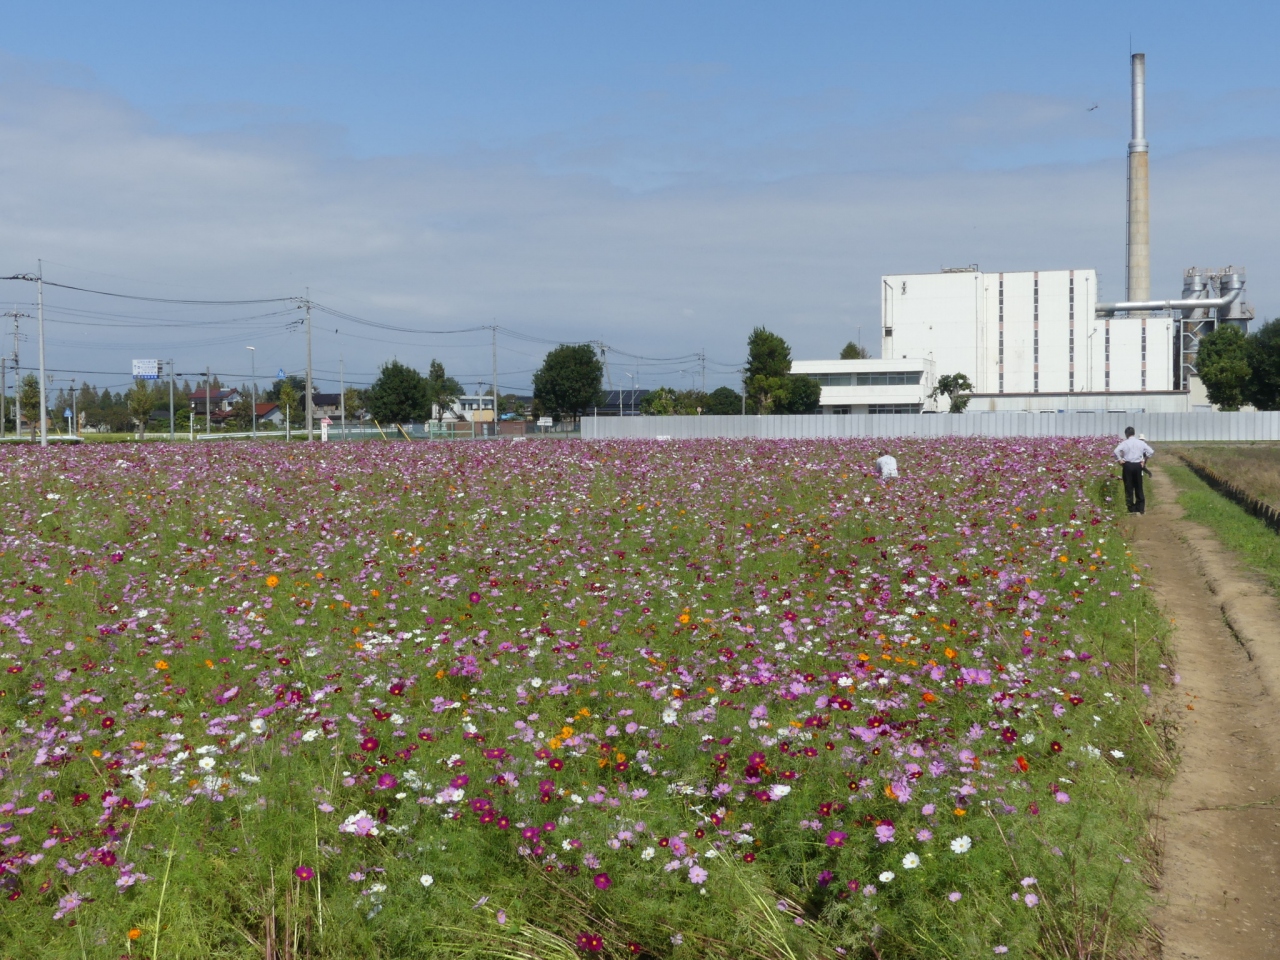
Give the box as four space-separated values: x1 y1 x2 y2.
792 266 1187 413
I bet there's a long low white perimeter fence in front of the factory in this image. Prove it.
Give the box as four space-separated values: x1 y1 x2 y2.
581 411 1280 443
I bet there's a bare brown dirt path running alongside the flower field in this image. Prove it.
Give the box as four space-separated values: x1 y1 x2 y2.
1133 470 1280 960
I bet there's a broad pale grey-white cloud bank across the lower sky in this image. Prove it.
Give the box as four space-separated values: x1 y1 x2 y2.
0 70 1280 394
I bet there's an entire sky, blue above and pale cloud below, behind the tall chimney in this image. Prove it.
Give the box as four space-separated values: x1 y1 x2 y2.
0 3 1280 389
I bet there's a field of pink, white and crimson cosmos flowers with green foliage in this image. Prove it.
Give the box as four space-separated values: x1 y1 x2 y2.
0 439 1170 959
